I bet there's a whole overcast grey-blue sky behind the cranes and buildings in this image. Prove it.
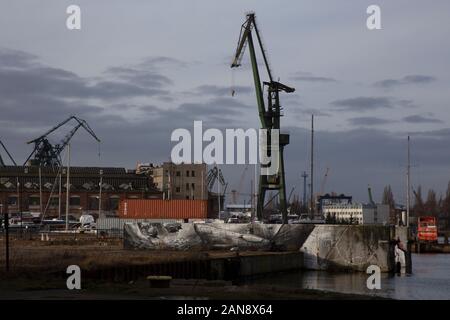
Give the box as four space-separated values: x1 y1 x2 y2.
0 0 450 202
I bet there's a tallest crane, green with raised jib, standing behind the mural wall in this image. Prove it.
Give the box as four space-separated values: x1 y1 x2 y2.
231 13 295 223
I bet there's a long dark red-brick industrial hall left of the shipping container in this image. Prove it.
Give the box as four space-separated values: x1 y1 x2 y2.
0 166 162 217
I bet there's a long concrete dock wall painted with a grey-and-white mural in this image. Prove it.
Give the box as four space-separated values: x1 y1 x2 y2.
124 223 411 275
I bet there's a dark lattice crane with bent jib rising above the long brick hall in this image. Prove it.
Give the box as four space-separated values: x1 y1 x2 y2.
24 116 100 167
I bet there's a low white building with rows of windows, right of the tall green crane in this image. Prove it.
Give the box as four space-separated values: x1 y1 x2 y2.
323 203 389 225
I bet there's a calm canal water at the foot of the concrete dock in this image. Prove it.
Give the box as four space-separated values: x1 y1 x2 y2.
248 254 450 300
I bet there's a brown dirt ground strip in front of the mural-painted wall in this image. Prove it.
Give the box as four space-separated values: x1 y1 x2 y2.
0 235 296 276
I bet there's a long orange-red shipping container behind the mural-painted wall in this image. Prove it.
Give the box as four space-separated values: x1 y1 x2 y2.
119 199 208 220
